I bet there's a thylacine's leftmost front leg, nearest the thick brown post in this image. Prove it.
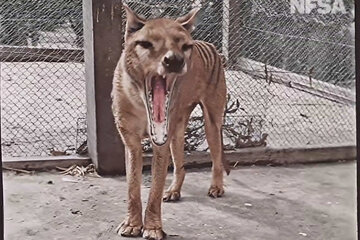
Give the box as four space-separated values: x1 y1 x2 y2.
117 127 143 237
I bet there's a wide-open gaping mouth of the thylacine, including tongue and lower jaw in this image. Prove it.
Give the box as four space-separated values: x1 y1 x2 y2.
145 74 175 146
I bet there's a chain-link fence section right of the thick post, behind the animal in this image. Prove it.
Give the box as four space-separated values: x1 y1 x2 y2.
126 0 355 150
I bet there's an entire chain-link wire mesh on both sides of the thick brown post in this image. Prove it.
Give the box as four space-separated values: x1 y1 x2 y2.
0 0 355 158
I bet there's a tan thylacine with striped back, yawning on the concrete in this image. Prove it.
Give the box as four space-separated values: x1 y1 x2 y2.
112 6 229 239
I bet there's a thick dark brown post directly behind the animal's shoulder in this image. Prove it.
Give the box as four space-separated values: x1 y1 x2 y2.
83 0 125 174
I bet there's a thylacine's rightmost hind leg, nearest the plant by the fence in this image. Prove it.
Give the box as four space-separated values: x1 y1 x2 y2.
203 100 224 198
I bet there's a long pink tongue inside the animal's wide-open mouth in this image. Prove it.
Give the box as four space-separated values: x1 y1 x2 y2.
153 77 165 123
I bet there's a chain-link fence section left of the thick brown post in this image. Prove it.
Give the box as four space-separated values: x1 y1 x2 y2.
0 0 86 157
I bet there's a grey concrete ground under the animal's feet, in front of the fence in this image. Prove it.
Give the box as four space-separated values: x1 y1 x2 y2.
4 162 356 240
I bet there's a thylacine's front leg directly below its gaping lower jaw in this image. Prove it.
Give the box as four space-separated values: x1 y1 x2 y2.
143 143 170 240
